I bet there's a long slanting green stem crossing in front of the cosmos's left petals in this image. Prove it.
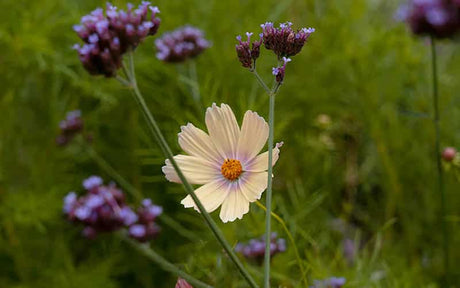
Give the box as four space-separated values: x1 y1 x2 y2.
122 51 258 288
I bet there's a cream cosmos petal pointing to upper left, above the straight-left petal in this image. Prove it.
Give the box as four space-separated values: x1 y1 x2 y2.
179 123 225 168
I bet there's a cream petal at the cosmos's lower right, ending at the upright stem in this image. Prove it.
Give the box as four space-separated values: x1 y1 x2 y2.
238 172 268 202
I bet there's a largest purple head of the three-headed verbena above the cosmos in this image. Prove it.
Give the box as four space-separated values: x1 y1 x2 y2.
260 22 315 59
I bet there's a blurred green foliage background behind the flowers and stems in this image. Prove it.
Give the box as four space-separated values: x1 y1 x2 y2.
0 0 460 288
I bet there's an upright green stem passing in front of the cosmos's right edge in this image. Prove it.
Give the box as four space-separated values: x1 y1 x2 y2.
264 88 275 288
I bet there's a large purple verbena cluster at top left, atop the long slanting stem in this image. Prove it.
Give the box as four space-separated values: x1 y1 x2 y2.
74 2 160 77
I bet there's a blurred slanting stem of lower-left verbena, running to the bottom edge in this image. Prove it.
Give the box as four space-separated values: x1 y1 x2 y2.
121 236 213 288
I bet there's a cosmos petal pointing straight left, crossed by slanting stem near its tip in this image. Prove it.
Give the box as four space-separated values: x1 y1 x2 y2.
161 155 221 184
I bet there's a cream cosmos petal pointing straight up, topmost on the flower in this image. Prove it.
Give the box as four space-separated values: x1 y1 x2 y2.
206 103 240 159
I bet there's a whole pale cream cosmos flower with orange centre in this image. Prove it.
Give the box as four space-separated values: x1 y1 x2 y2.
162 104 282 223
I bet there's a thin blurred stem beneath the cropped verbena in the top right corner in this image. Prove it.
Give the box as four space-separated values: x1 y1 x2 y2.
430 36 450 283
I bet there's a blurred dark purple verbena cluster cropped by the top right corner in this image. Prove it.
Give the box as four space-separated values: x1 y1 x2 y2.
397 0 460 38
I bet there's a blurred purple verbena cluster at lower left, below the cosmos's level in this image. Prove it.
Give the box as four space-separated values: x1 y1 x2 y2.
63 176 162 242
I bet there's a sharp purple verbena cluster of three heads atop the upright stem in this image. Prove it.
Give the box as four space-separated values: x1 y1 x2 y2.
235 22 315 84
